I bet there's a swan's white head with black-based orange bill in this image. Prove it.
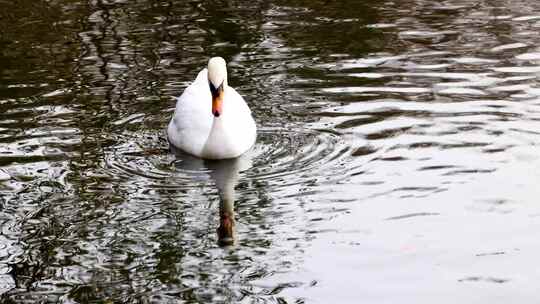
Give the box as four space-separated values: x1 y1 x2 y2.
208 57 227 117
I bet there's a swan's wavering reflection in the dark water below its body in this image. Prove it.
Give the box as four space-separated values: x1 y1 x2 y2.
171 147 251 246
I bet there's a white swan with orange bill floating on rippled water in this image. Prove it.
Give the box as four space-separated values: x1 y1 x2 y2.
167 57 257 159
